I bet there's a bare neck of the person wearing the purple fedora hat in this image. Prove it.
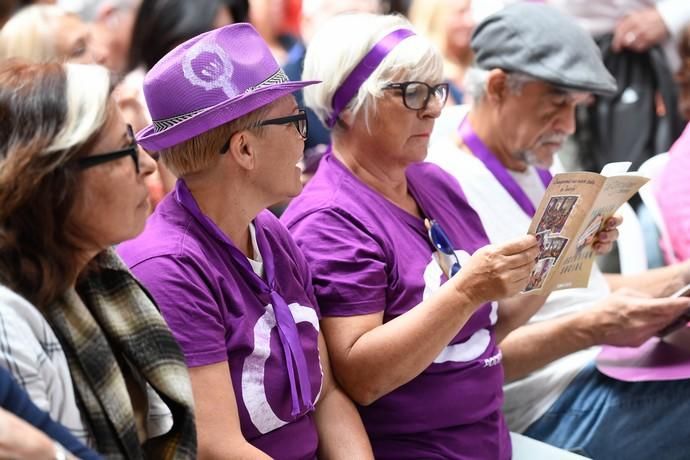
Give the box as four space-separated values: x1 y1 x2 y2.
184 167 270 258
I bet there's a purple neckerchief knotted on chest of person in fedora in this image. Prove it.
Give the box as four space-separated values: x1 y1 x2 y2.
175 179 314 417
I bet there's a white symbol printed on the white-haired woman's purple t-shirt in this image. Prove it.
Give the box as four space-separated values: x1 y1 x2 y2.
422 250 498 364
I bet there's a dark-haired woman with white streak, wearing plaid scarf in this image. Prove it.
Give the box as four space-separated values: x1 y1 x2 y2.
0 60 196 458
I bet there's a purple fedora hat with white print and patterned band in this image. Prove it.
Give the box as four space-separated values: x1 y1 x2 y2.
137 24 319 152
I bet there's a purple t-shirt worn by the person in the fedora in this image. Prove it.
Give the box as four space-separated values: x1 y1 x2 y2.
118 180 322 459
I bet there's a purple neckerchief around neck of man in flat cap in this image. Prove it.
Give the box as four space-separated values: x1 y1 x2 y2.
458 117 552 217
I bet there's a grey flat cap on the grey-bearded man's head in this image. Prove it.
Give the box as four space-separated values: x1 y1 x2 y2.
471 2 616 95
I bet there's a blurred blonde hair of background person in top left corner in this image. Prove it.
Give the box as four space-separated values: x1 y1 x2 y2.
0 5 67 62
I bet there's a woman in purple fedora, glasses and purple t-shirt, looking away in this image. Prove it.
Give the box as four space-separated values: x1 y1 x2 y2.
118 24 372 459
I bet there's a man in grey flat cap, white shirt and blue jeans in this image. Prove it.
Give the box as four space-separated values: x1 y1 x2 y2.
429 2 690 459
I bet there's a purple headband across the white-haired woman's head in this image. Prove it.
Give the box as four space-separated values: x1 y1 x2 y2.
326 29 415 128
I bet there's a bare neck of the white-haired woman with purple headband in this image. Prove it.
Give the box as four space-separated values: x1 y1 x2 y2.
333 133 417 209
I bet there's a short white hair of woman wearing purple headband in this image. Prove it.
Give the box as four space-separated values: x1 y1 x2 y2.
302 13 443 134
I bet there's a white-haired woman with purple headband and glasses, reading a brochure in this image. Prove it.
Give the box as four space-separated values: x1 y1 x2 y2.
283 14 537 459
